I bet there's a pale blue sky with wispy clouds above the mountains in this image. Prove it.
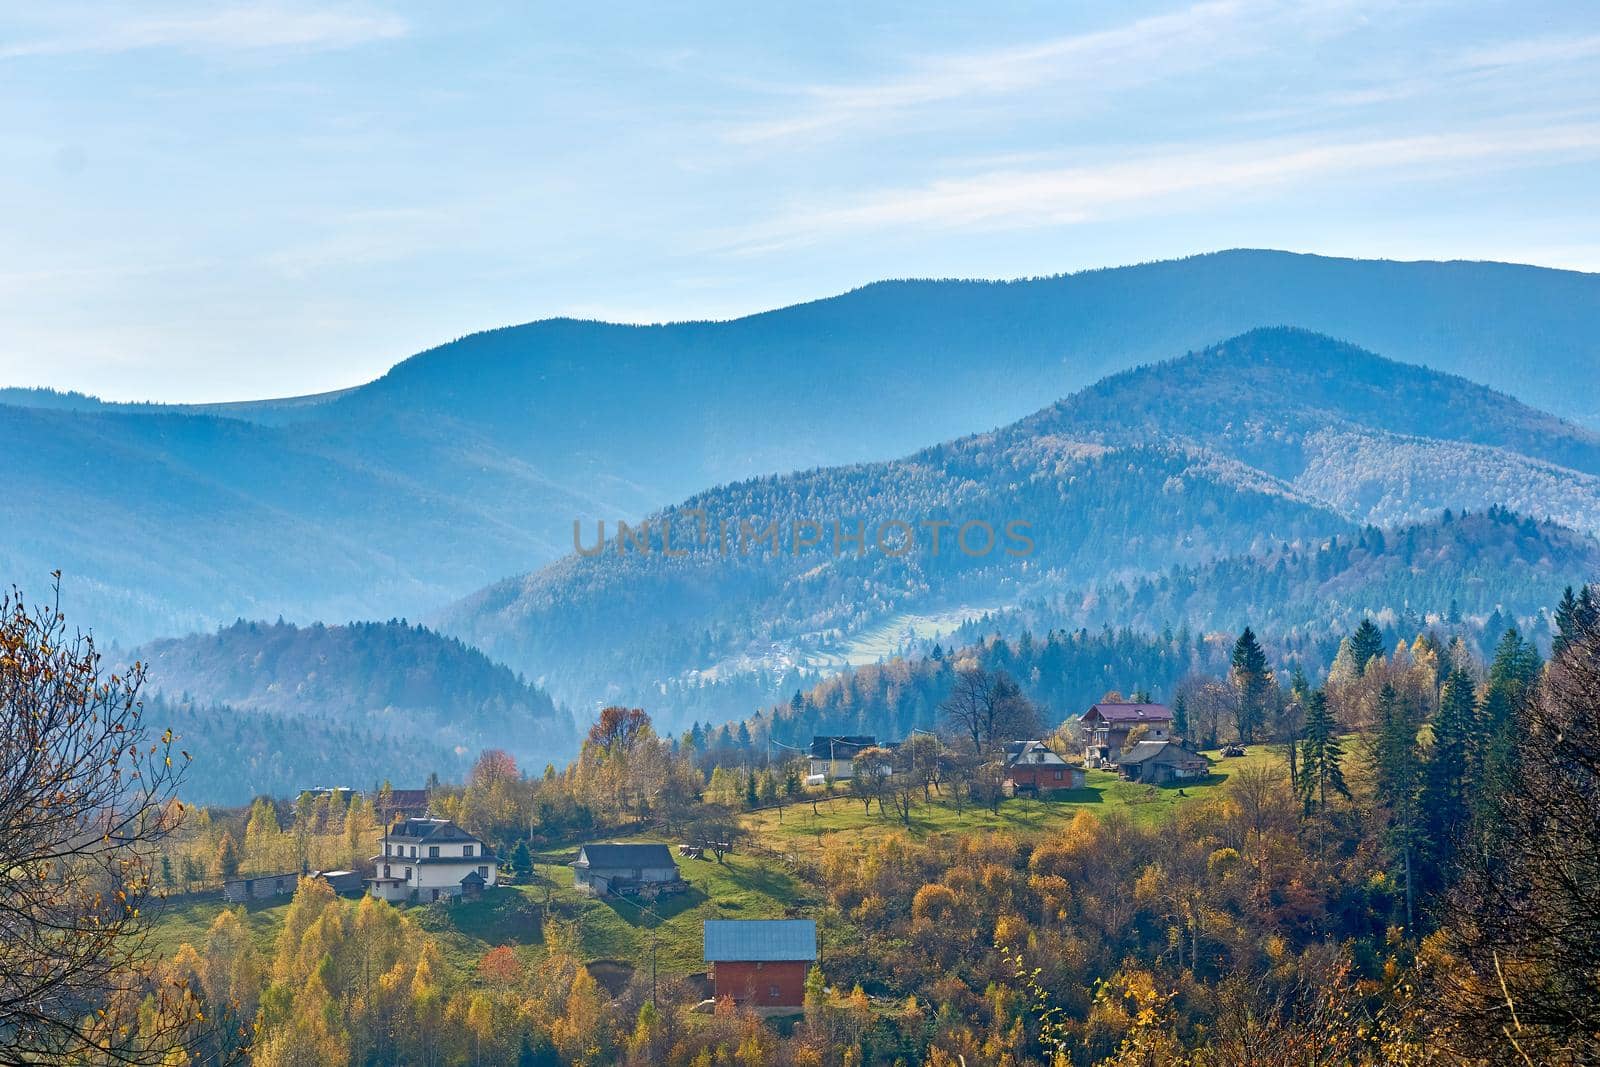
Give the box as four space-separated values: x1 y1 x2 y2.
0 0 1600 402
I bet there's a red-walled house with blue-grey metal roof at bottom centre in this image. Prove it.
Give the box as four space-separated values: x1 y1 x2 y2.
706 918 816 1008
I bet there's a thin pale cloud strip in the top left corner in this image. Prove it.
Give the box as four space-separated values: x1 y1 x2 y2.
0 3 408 59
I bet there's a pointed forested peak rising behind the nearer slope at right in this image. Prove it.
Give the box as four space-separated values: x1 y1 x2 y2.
1008 328 1600 533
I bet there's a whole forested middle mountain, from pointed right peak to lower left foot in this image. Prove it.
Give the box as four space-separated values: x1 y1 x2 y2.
442 335 1600 735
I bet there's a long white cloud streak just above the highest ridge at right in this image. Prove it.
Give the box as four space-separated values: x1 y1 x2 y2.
723 123 1600 253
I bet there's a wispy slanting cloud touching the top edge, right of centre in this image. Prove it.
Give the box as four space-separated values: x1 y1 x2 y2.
728 0 1368 144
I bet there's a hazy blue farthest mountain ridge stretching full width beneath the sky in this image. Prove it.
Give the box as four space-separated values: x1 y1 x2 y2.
0 251 1600 641
